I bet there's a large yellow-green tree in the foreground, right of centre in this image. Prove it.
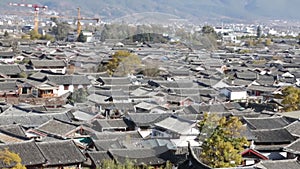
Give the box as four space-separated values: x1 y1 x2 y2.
198 114 249 168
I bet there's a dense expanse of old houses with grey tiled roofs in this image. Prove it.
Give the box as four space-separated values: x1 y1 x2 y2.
0 37 300 169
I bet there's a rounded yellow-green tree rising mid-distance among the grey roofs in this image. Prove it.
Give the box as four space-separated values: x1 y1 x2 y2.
106 50 141 76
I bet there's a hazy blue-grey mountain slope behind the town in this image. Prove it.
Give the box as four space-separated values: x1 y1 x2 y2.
0 0 300 22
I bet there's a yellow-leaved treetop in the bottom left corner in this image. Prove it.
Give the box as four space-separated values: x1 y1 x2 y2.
0 149 26 169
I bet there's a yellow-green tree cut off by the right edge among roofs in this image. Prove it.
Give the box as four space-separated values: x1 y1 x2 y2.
282 86 300 112
